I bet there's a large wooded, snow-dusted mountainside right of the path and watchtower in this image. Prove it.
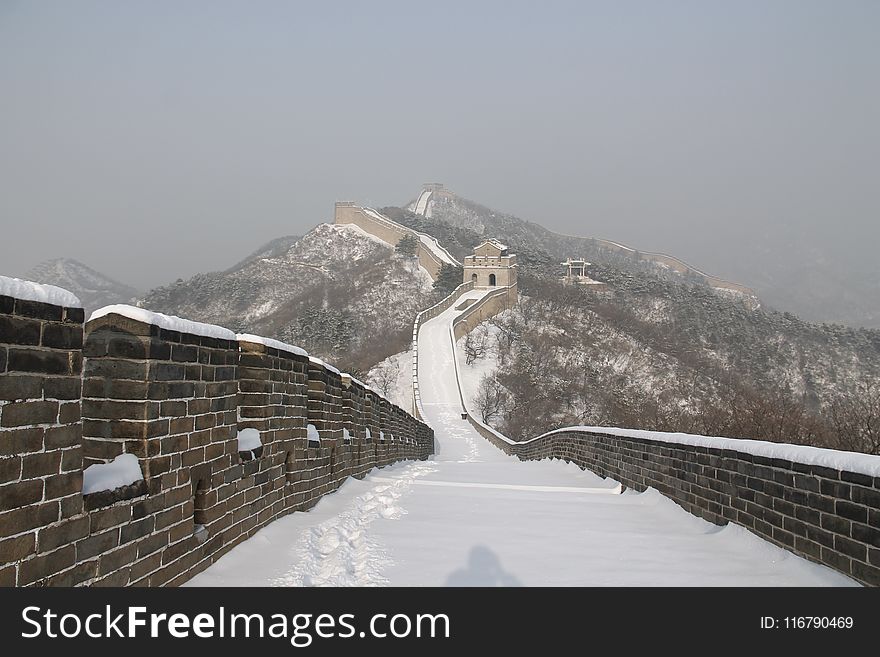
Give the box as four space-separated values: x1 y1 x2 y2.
394 192 880 453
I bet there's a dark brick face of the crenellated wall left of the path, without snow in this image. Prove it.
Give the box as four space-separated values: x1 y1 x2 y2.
0 297 434 586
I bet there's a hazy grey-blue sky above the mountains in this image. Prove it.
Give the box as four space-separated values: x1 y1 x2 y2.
0 0 880 288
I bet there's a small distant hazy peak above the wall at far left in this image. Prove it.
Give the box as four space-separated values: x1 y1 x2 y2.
25 258 140 317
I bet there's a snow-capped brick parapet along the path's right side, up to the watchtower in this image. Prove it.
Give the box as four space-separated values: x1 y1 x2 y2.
447 289 880 586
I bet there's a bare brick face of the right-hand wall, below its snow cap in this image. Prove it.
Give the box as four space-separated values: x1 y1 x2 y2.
471 420 880 586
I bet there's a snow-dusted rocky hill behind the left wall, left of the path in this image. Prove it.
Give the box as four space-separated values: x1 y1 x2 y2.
141 224 439 373
